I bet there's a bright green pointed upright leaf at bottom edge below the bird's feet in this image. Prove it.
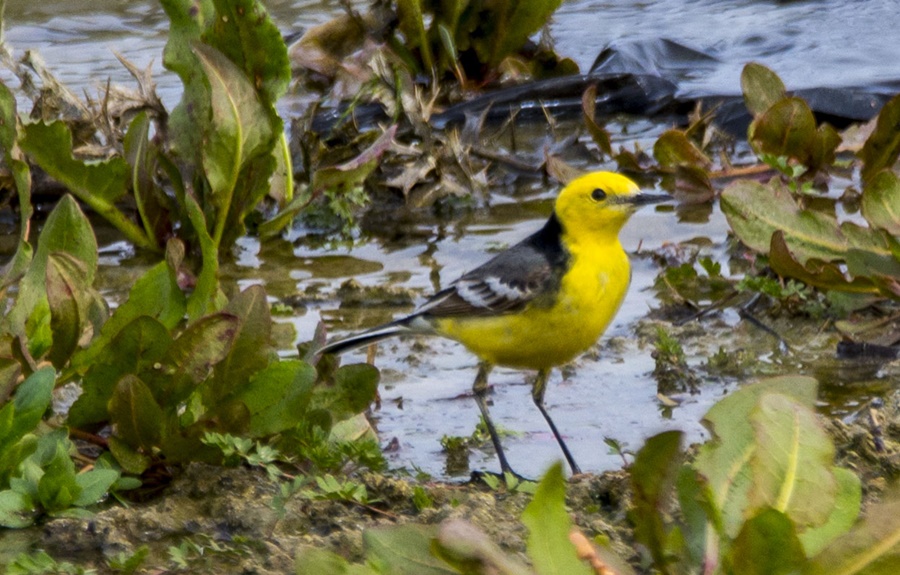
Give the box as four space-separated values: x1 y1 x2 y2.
522 462 591 575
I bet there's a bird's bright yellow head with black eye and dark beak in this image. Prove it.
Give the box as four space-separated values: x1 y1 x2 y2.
554 172 668 241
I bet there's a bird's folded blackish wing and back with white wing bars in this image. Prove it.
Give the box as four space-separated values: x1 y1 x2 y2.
414 215 568 317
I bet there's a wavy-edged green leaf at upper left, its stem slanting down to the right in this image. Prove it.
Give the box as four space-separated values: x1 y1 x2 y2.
19 121 156 250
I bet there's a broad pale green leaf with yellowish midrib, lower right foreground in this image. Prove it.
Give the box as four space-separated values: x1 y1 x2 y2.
749 393 837 530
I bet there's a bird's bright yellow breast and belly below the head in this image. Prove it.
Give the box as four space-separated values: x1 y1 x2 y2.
435 241 631 369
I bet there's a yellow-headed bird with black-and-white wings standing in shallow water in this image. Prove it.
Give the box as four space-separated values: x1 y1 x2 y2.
320 172 668 473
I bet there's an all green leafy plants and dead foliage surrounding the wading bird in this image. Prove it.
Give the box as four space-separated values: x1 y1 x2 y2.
0 0 900 575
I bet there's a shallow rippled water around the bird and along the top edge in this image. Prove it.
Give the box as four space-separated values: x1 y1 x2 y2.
0 0 900 476
